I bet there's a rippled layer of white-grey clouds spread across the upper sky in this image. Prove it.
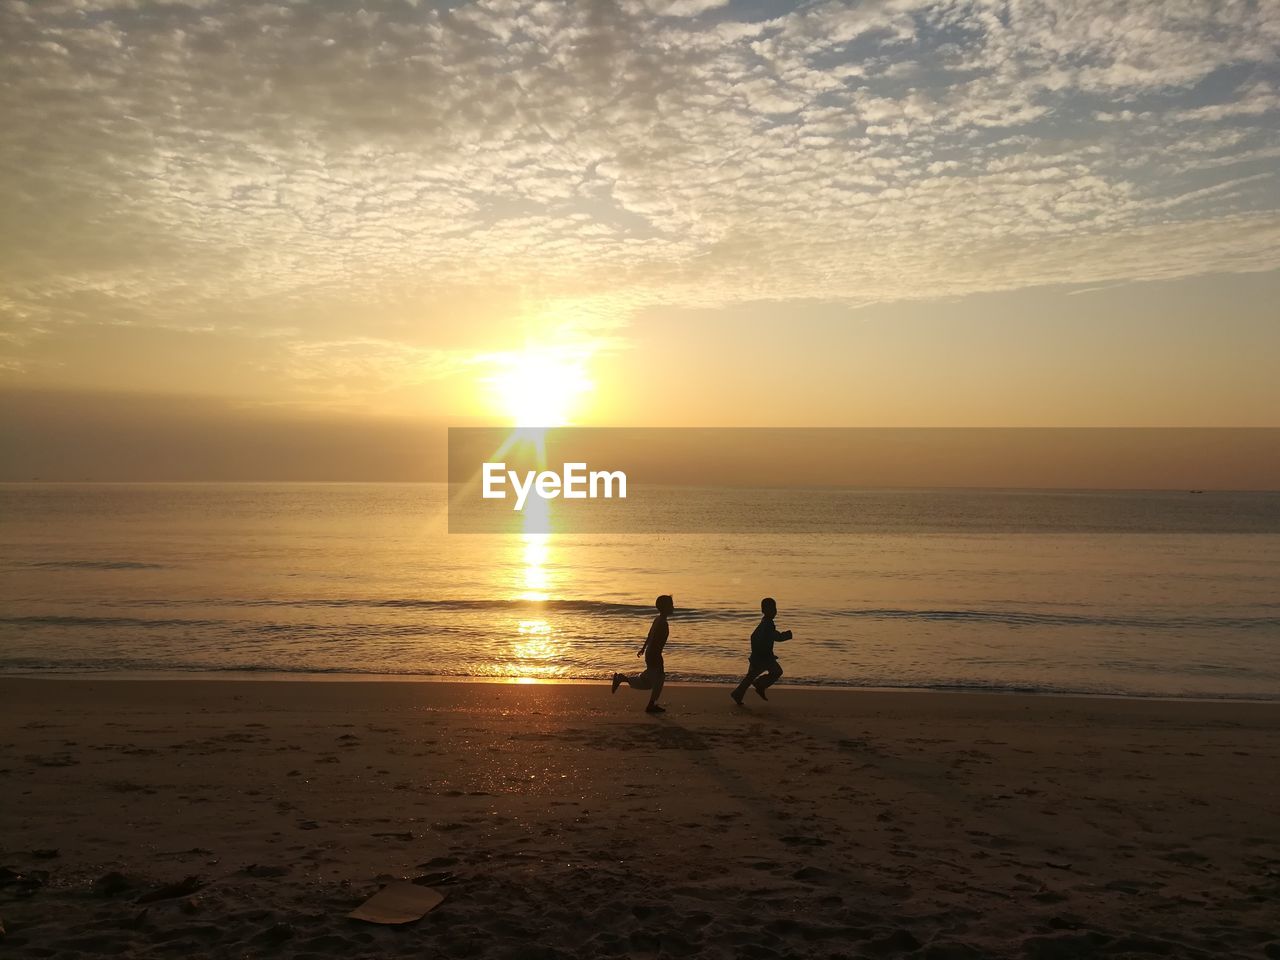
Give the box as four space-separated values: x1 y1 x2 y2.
0 0 1280 394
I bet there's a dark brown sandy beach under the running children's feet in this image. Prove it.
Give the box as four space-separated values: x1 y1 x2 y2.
0 678 1280 960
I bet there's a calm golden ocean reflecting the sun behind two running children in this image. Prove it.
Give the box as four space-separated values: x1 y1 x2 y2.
0 484 1280 700
